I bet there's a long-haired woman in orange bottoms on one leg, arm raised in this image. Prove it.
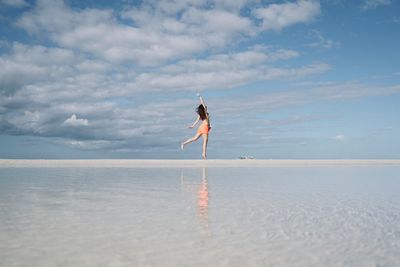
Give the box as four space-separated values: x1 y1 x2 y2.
181 93 211 159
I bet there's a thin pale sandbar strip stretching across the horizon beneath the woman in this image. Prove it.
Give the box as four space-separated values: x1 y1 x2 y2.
0 159 400 168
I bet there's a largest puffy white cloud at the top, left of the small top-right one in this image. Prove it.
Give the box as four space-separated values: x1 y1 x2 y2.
17 0 254 66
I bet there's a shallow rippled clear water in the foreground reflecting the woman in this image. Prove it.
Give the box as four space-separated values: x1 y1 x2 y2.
0 166 400 267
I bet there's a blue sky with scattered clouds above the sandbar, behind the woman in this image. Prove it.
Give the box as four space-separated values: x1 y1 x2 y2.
0 0 400 159
